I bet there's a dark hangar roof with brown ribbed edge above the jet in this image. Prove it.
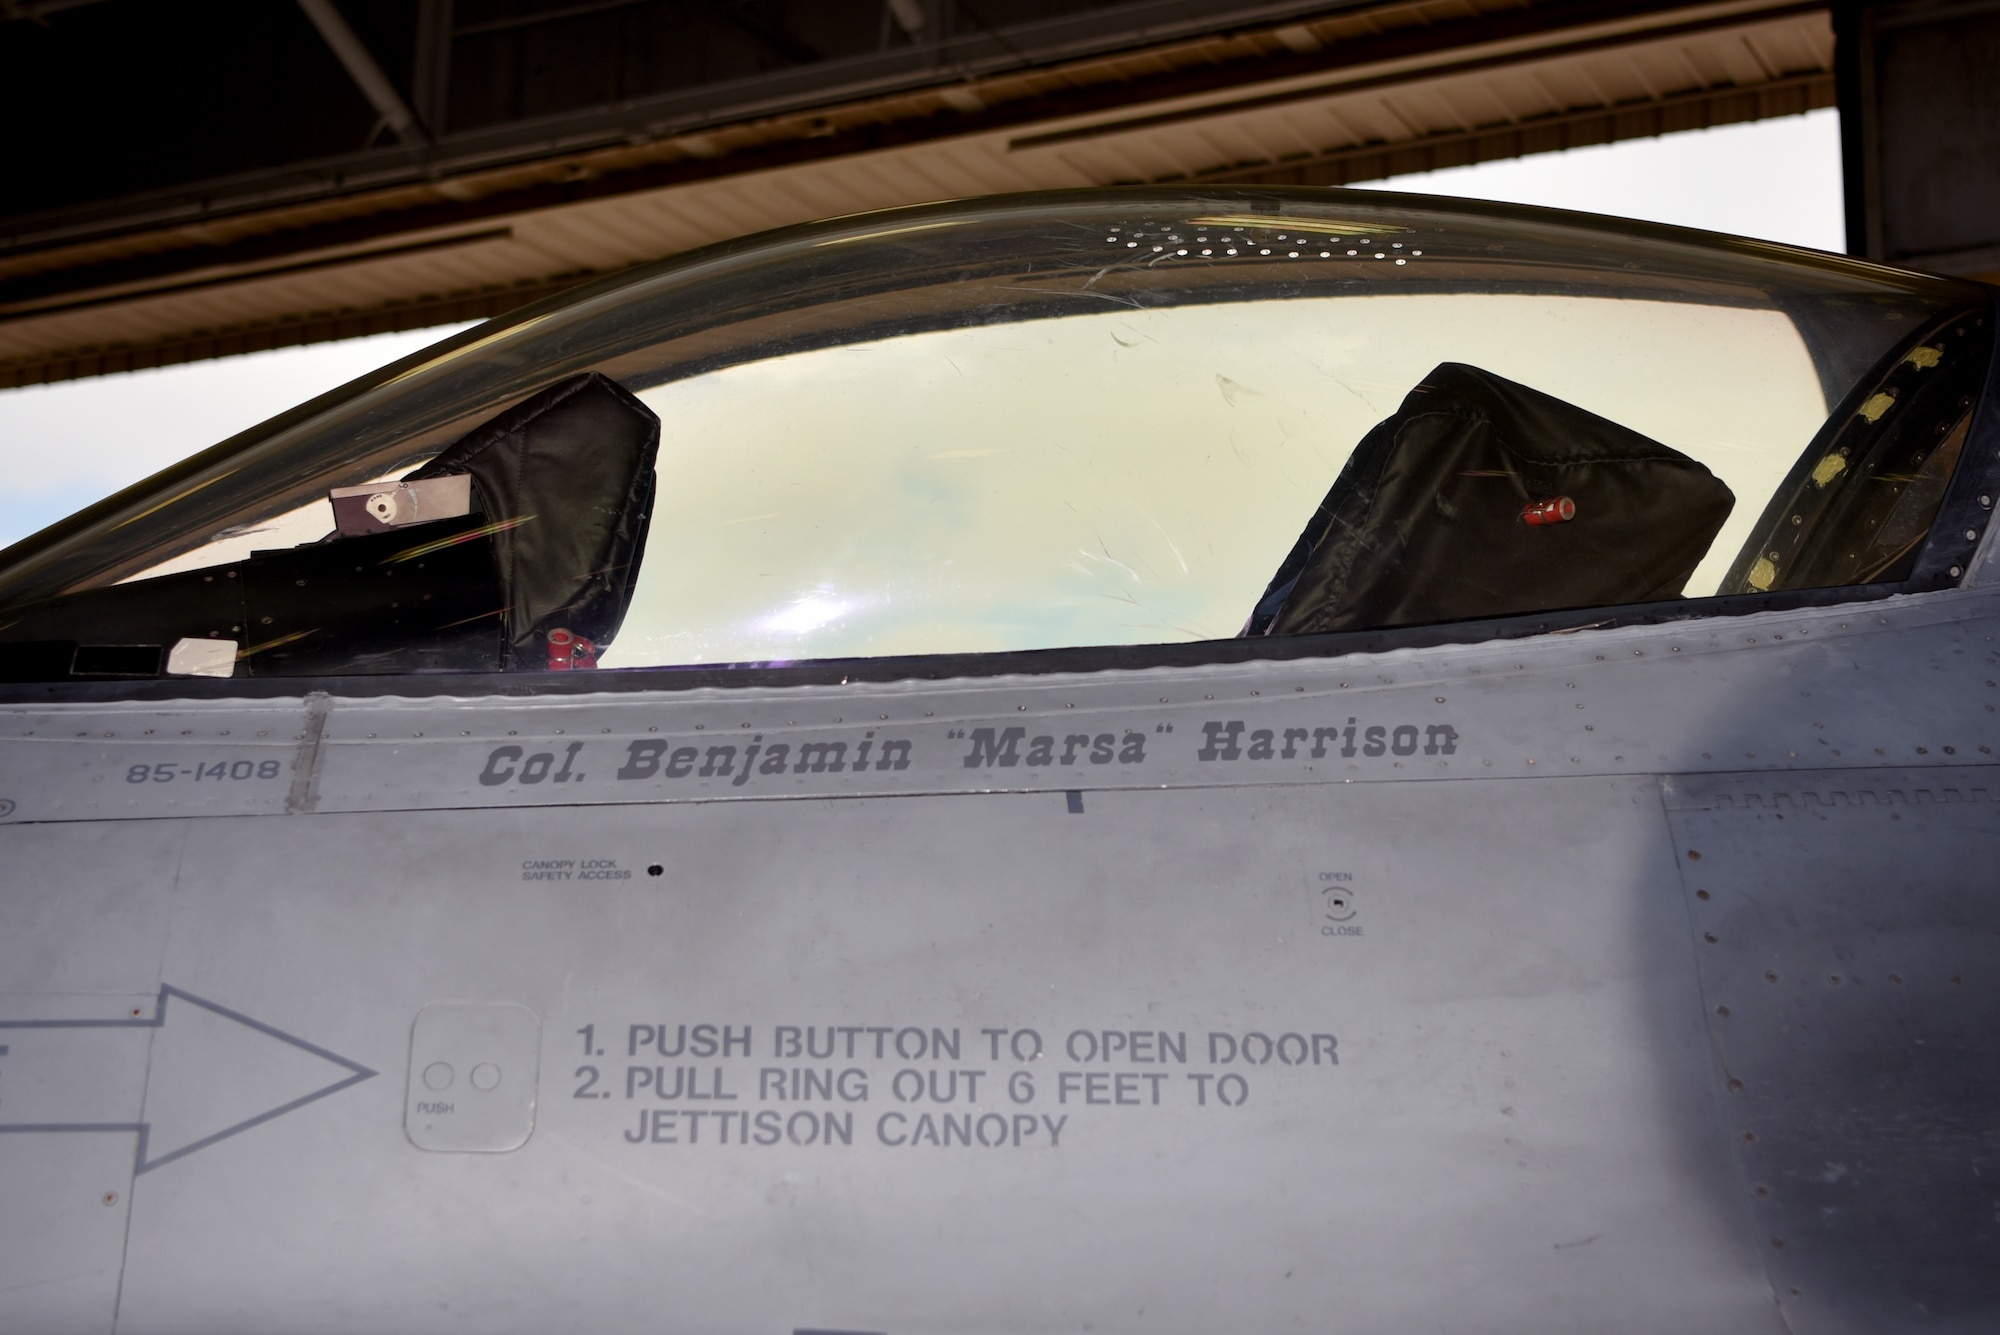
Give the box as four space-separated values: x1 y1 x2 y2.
0 0 1834 386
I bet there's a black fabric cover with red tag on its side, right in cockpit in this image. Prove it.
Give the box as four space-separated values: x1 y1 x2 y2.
1246 362 1736 636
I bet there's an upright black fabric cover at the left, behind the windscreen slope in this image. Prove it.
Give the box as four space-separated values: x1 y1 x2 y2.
410 372 660 669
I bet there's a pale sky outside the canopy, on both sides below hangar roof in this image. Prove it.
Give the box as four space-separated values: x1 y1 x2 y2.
0 110 1844 548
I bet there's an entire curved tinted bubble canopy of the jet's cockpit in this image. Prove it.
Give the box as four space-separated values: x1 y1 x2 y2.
0 190 1992 681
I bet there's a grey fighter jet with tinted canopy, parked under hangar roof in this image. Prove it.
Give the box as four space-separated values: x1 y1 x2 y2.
0 188 2000 1335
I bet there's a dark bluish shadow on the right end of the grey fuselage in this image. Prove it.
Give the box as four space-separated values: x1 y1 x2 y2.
1662 622 2000 1335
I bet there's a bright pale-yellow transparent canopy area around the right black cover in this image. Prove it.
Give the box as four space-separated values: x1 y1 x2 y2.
604 294 1826 668
